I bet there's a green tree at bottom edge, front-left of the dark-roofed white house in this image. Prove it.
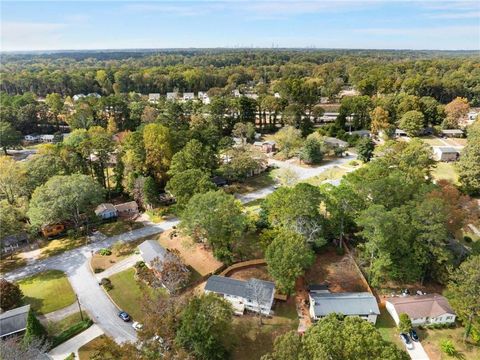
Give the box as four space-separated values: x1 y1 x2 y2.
175 294 233 360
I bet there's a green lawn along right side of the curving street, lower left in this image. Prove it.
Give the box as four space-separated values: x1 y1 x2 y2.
108 268 164 322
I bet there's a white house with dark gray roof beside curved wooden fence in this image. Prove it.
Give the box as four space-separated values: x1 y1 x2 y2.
205 275 275 315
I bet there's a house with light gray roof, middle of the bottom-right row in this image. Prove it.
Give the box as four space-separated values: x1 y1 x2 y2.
309 291 380 324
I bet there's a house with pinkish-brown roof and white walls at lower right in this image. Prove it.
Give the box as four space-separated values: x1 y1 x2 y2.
385 294 456 326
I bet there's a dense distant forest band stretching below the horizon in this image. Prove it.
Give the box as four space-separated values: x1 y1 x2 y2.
0 50 480 105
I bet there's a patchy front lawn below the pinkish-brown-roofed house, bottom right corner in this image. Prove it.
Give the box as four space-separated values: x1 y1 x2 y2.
418 326 480 360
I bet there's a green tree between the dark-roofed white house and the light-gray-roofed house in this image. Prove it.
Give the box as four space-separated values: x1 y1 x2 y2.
265 229 315 294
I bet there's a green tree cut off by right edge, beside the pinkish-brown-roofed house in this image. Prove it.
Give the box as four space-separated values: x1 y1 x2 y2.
446 255 480 339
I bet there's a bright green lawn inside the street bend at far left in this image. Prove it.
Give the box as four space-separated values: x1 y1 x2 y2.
18 270 75 314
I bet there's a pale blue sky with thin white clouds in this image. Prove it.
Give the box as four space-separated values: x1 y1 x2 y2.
0 0 480 51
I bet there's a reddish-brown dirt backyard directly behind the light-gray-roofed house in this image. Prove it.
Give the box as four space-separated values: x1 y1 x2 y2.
305 248 368 292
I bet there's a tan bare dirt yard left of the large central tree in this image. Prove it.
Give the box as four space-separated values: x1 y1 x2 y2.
158 230 223 276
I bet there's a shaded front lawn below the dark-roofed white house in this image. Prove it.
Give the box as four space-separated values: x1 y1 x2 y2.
232 302 298 360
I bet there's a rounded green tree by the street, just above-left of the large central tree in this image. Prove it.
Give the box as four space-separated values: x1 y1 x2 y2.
165 169 215 208
